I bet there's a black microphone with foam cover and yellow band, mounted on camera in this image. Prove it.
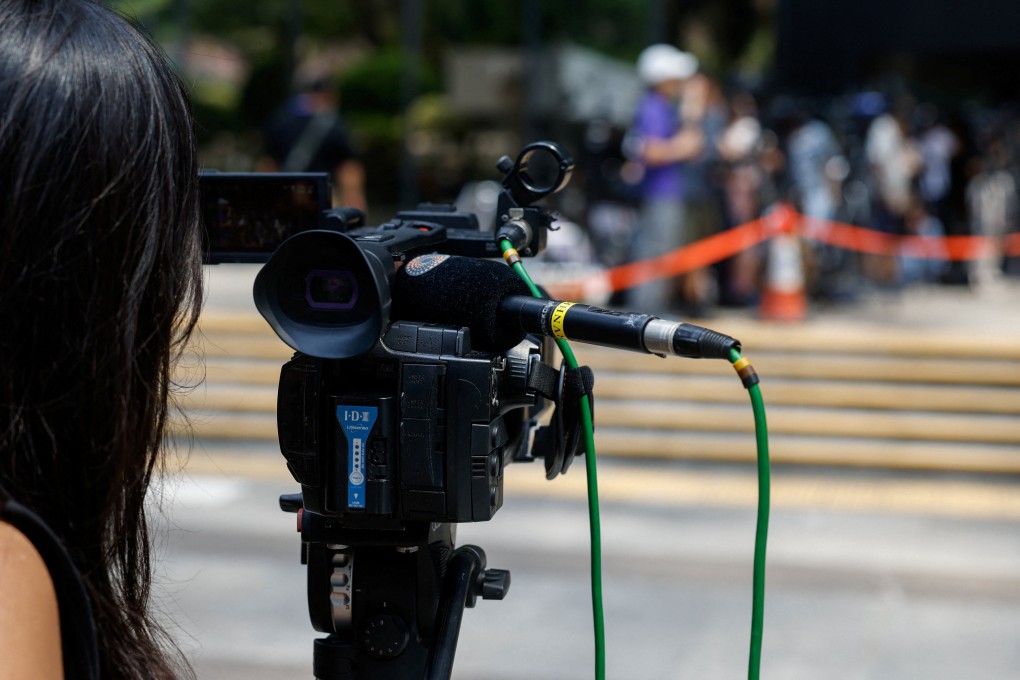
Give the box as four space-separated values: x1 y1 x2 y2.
393 255 741 360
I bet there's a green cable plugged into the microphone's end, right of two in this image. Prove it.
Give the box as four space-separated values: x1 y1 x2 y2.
729 350 771 680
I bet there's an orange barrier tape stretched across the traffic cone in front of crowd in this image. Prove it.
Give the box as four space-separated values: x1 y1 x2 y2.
549 204 1020 299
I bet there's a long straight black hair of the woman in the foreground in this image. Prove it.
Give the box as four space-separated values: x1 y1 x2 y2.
0 0 202 678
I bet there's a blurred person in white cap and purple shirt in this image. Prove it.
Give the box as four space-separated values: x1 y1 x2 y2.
626 44 704 314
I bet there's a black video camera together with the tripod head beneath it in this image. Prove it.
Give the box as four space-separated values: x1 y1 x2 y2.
201 142 580 679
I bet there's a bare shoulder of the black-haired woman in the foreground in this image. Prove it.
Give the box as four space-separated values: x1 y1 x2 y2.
0 521 63 680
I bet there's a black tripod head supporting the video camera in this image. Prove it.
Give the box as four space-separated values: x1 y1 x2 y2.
281 494 510 680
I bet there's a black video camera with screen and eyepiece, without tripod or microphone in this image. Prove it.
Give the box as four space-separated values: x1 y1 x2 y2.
201 142 573 530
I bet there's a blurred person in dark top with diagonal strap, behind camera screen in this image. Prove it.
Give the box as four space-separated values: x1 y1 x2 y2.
259 76 368 212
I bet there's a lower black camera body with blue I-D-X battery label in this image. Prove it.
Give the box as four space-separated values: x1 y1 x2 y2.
277 321 543 530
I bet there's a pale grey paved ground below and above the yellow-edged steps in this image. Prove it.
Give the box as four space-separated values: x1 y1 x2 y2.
179 265 1020 680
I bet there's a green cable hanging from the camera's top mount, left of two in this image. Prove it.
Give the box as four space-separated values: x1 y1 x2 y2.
500 239 606 680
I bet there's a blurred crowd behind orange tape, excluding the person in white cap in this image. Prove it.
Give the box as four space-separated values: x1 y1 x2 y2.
583 73 1020 308
